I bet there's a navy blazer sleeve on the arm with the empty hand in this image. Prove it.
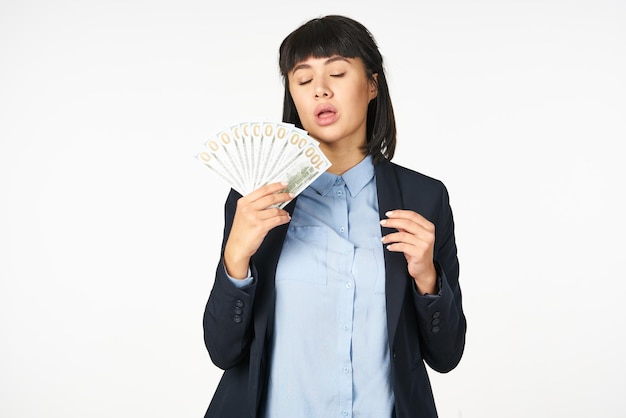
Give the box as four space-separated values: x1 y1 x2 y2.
413 182 467 373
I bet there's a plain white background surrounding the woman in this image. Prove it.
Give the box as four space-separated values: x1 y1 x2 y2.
0 0 626 418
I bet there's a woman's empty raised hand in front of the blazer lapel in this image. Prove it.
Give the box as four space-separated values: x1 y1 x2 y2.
380 209 437 294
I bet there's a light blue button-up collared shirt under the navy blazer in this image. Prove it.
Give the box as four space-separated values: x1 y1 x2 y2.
265 157 393 418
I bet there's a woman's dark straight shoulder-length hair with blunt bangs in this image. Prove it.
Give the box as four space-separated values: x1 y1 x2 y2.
278 15 396 162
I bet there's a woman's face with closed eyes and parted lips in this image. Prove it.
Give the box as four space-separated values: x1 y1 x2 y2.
288 56 377 152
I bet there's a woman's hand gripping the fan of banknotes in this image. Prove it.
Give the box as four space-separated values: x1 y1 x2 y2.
224 183 294 279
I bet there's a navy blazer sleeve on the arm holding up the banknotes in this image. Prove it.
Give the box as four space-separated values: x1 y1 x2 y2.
203 190 256 370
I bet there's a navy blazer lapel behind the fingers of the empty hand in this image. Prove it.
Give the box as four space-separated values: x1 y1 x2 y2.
375 161 408 347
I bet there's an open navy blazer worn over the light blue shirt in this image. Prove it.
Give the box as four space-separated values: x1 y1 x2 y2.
203 161 466 418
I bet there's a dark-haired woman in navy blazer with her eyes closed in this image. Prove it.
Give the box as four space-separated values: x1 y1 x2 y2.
204 16 466 418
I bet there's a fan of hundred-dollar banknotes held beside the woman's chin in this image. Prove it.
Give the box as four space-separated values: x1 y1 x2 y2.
196 121 331 207
